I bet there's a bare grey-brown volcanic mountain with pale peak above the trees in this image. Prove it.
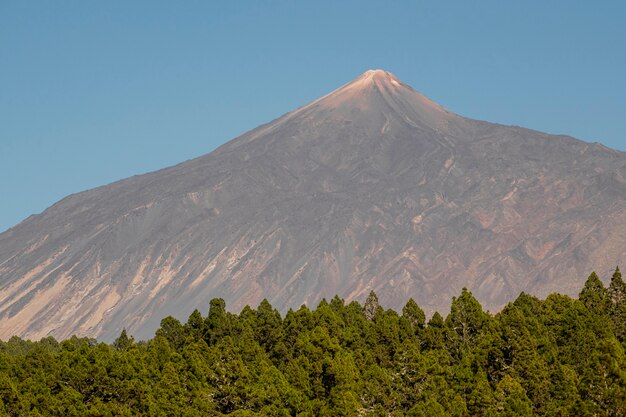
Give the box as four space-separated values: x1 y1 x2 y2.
0 71 626 341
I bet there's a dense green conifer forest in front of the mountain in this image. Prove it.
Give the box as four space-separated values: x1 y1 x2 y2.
0 270 626 417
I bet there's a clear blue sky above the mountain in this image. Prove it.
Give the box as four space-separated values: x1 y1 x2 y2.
0 0 626 231
